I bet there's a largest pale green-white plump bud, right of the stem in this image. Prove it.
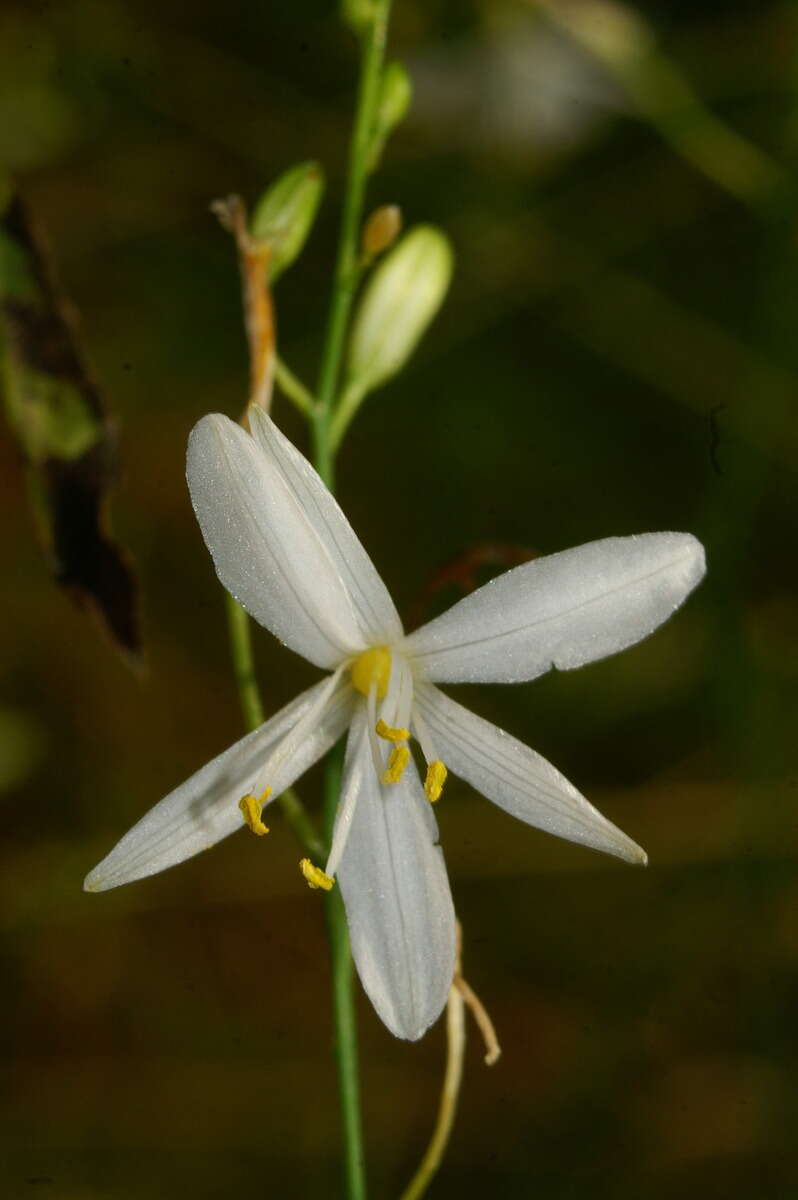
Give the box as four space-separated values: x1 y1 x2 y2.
348 226 452 395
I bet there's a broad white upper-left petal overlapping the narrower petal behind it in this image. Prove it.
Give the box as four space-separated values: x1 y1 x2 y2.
187 413 367 667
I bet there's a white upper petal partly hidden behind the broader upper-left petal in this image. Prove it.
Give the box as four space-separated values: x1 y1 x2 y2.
250 408 402 646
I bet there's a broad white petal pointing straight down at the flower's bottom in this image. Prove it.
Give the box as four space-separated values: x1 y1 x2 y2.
337 703 455 1040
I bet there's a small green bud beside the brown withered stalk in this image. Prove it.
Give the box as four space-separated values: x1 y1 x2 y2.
251 162 324 283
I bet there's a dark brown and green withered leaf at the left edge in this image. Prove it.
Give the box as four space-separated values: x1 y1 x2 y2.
0 197 140 665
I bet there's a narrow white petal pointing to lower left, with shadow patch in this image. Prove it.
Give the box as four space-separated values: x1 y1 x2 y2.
83 679 354 892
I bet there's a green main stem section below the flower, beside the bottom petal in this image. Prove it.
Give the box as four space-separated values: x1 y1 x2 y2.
324 745 366 1200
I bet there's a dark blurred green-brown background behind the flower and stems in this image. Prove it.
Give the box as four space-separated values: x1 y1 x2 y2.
0 0 798 1200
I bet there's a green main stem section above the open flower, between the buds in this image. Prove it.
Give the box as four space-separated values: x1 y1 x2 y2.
313 0 390 486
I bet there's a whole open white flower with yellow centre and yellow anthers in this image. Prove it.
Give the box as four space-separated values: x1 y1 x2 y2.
85 409 704 1039
